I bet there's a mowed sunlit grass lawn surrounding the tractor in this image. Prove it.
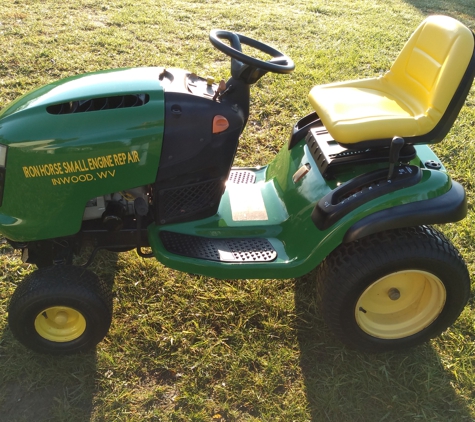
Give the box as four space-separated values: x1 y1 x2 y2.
0 0 475 422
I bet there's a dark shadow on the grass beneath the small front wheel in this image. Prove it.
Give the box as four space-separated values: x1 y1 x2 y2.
0 254 116 422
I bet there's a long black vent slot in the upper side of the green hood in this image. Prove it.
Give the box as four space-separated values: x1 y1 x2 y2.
46 94 150 114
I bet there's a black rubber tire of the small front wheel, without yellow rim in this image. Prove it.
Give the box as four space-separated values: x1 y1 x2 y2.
8 265 112 355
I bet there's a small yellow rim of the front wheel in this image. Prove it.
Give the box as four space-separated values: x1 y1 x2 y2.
35 306 86 343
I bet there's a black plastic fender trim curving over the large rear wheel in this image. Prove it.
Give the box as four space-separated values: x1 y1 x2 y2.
343 181 467 243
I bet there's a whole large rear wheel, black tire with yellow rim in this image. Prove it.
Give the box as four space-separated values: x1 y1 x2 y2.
317 226 470 351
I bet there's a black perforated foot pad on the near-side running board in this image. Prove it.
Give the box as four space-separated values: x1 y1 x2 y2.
160 231 277 262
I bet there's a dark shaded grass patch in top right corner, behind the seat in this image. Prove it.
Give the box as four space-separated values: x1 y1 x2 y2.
405 0 475 23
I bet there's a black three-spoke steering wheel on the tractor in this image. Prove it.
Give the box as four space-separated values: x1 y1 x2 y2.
209 29 295 76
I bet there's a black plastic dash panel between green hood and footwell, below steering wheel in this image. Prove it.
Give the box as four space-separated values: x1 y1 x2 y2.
153 74 245 224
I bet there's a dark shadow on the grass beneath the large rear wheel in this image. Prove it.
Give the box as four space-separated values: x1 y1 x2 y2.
295 273 473 422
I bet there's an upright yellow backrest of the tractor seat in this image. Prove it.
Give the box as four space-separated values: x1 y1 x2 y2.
383 15 475 143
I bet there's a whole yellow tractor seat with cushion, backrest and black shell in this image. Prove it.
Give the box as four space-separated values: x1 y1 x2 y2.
309 16 475 148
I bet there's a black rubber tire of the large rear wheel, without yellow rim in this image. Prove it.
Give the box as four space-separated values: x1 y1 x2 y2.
317 226 470 352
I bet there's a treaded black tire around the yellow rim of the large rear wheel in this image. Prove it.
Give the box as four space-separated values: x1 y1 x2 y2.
317 226 470 351
